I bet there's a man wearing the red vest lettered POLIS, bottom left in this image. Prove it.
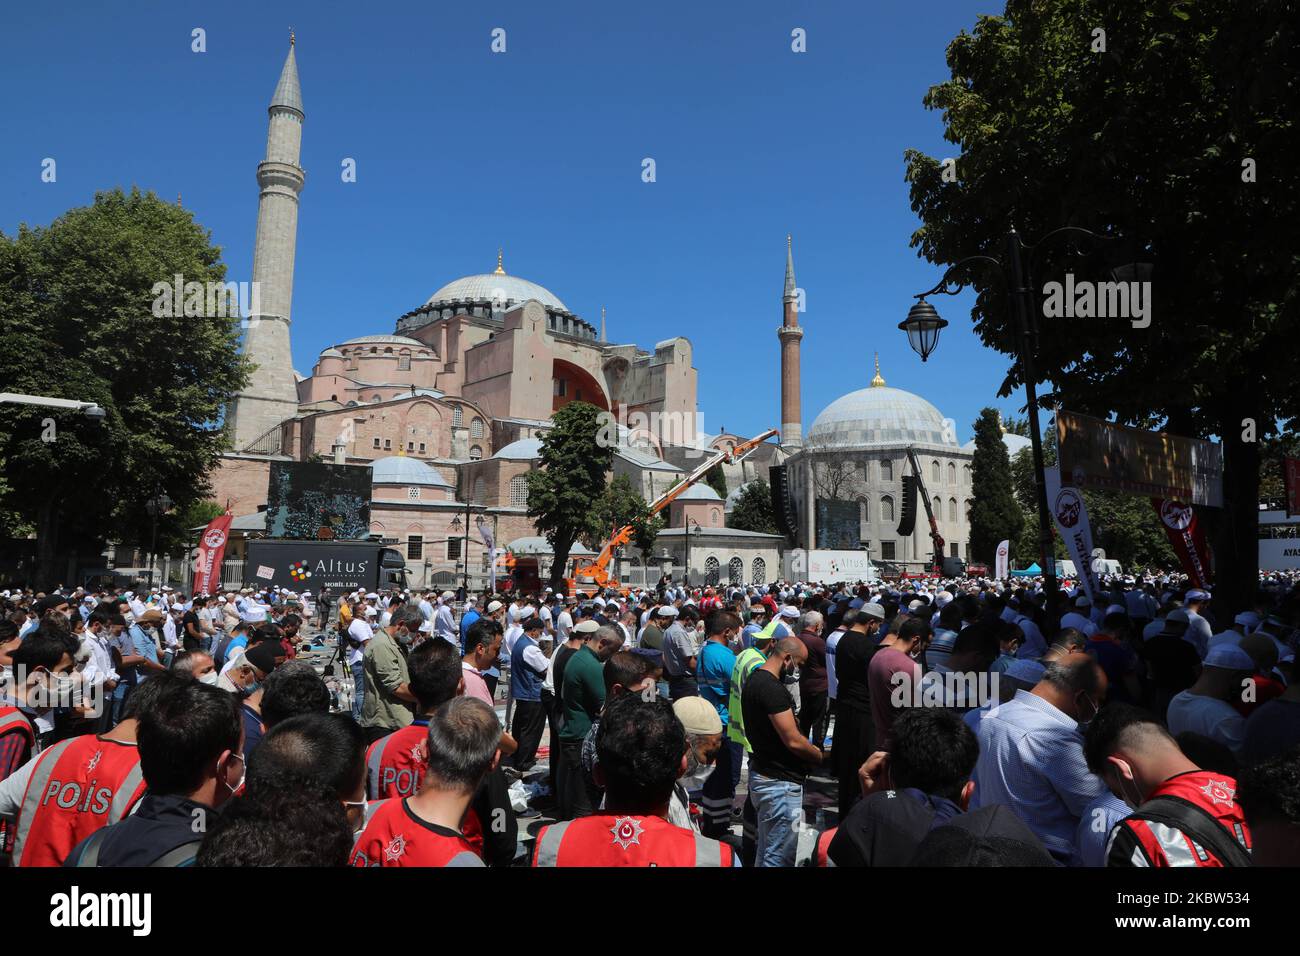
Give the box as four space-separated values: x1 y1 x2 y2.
0 674 181 866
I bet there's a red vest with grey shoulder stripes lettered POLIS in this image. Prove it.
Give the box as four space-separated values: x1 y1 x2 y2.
13 734 144 866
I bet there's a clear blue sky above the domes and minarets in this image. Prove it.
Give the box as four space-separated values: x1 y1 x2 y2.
0 0 1023 442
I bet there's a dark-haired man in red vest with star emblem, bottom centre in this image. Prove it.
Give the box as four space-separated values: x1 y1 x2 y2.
533 695 738 866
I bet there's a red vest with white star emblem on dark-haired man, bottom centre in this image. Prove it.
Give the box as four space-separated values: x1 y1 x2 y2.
533 816 735 866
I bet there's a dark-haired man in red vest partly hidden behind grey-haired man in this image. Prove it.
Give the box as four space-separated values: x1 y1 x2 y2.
365 640 519 866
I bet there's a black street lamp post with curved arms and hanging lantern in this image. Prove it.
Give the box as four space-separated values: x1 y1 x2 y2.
898 226 1144 618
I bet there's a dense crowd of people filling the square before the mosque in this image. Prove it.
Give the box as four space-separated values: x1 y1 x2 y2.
0 574 1300 866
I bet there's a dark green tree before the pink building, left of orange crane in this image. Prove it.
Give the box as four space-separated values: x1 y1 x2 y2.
528 402 614 591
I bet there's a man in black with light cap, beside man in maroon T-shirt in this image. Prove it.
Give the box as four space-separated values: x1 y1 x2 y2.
831 604 885 819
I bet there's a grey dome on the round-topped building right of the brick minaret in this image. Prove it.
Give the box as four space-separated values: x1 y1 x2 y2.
803 385 957 449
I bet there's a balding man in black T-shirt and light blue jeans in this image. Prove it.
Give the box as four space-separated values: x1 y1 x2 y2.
741 637 823 866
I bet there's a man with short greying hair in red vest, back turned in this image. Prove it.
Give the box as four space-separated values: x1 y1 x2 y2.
352 697 501 866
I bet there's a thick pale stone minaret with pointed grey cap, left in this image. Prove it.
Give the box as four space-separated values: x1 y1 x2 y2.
229 33 307 451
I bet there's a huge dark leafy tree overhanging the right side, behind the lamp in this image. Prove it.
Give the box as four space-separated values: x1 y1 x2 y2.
906 0 1300 609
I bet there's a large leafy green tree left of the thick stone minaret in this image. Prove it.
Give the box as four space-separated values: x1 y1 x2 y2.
0 189 248 585
